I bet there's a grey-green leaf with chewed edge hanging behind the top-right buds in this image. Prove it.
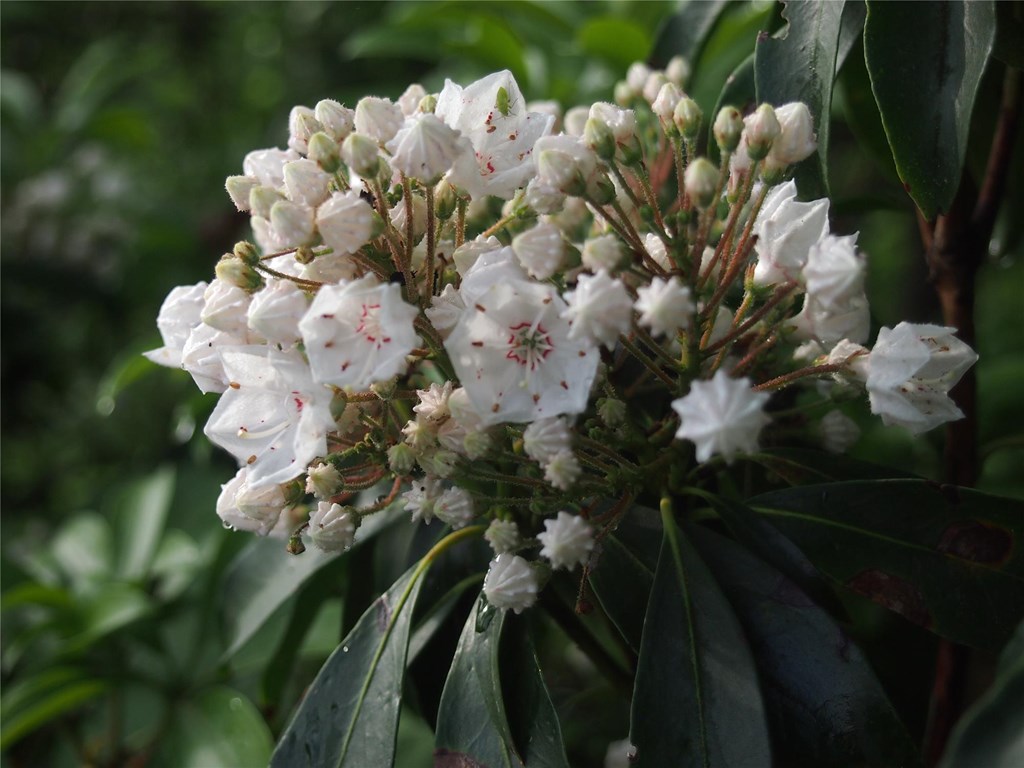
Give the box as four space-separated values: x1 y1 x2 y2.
755 0 844 198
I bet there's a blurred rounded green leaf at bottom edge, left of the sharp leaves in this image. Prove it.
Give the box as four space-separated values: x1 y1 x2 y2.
157 686 273 768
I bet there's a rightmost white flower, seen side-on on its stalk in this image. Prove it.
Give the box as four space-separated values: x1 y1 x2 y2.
867 323 978 434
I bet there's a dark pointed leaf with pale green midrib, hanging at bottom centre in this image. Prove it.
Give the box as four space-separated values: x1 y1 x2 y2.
630 507 771 768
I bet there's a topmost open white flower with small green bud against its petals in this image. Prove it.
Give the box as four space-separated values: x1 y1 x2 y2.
434 70 555 200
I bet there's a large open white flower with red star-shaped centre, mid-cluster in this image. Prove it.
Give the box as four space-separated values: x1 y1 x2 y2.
444 281 598 425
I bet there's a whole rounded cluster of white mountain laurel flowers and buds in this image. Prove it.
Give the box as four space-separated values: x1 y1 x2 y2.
146 59 976 612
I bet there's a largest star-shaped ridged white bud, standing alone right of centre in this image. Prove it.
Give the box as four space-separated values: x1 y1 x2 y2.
672 370 769 463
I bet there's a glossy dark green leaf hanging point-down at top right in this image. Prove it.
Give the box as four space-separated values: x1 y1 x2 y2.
864 0 995 219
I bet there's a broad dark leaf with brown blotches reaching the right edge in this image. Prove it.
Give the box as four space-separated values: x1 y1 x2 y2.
750 480 1024 649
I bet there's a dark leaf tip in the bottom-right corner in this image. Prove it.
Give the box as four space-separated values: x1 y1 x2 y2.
939 624 1024 768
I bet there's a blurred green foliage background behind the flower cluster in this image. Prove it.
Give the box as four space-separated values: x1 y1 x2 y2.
0 0 1024 767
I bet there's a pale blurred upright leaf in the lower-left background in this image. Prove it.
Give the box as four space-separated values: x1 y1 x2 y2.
115 467 174 581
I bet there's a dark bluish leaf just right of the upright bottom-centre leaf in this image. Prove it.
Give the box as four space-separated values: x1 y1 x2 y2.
690 526 919 768
